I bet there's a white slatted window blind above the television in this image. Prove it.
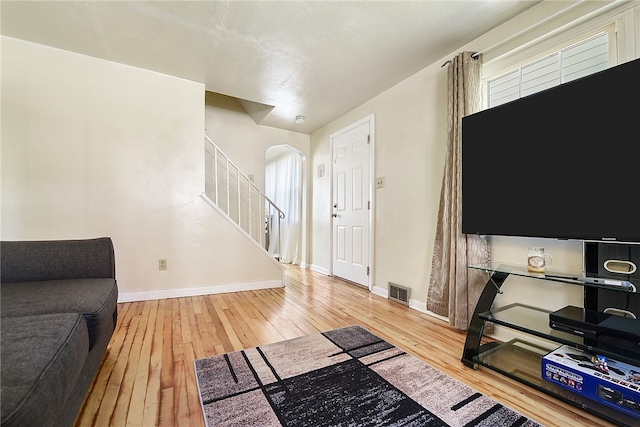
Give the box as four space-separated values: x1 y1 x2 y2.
487 33 609 108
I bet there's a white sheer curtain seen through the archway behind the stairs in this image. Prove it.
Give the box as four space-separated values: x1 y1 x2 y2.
265 152 302 264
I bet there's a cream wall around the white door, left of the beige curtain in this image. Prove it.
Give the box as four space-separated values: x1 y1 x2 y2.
311 68 446 301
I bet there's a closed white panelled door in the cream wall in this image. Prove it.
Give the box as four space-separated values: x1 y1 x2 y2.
331 120 371 286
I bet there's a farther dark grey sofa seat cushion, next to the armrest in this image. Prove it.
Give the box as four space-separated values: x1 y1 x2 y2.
0 279 118 349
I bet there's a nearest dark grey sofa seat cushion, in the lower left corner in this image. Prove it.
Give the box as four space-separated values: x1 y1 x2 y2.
0 312 89 427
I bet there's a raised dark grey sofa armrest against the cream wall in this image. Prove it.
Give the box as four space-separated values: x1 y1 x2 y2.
0 237 116 282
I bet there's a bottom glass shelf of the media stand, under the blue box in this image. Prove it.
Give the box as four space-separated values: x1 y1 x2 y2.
474 339 638 426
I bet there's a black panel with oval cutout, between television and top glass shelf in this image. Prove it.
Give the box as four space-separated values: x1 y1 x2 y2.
583 242 640 283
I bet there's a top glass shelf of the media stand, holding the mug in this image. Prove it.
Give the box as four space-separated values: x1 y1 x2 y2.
469 263 640 292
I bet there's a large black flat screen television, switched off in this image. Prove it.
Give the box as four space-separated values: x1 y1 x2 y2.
462 59 640 243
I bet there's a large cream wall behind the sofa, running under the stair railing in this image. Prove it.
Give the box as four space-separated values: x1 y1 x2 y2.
1 37 282 299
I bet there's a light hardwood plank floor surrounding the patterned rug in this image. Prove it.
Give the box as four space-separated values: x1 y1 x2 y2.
75 267 610 427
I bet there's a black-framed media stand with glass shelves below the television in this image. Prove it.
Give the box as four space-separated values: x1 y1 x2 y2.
462 264 640 426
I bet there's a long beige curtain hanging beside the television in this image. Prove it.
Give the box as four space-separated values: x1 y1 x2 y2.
427 52 490 330
